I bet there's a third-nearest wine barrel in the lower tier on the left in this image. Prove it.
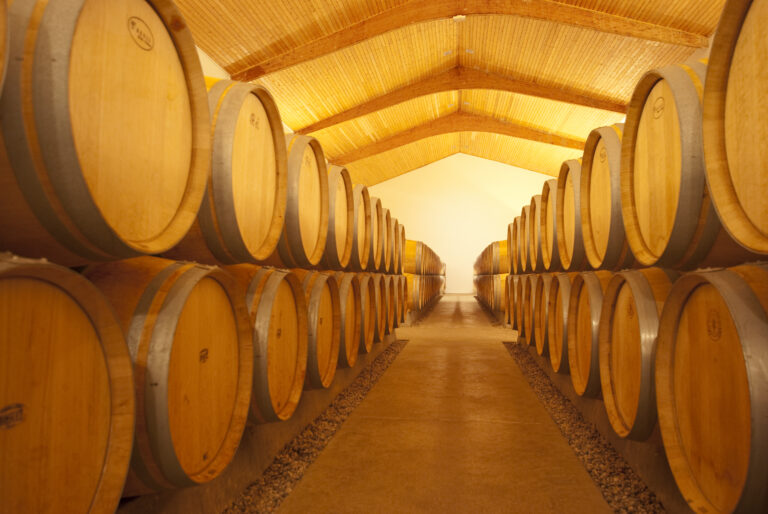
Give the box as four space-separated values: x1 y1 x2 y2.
227 264 309 423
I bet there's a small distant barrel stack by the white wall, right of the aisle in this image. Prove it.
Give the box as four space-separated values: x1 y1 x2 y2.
474 240 510 323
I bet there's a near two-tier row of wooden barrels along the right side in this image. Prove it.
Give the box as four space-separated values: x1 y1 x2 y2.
504 1 768 512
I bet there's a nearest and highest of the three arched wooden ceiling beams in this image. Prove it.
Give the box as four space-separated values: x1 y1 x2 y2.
232 0 708 81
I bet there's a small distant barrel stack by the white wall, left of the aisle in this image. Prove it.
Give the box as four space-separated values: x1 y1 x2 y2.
403 239 445 319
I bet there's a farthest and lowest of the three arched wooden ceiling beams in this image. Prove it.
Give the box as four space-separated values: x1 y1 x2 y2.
329 112 584 166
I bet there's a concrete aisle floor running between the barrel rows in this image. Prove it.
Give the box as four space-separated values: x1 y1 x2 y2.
280 295 610 513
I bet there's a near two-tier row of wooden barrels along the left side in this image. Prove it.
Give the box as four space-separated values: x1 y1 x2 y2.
0 0 414 512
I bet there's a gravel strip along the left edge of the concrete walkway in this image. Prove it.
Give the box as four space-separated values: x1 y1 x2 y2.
223 341 408 514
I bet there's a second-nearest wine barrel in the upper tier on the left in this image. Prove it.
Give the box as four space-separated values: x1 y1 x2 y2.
163 79 287 264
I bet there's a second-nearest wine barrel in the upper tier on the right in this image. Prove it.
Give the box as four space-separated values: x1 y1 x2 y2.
621 62 753 269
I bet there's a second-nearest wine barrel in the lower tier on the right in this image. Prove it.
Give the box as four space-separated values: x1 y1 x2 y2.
598 268 679 441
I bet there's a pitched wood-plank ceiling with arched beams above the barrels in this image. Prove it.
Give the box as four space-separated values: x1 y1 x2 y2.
177 0 725 185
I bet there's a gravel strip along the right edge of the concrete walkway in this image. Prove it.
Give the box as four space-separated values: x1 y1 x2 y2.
504 343 665 513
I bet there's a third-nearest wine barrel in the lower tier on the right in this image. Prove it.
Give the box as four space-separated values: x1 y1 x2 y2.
566 271 612 397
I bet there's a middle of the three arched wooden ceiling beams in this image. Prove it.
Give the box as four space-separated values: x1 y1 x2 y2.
296 66 627 134
